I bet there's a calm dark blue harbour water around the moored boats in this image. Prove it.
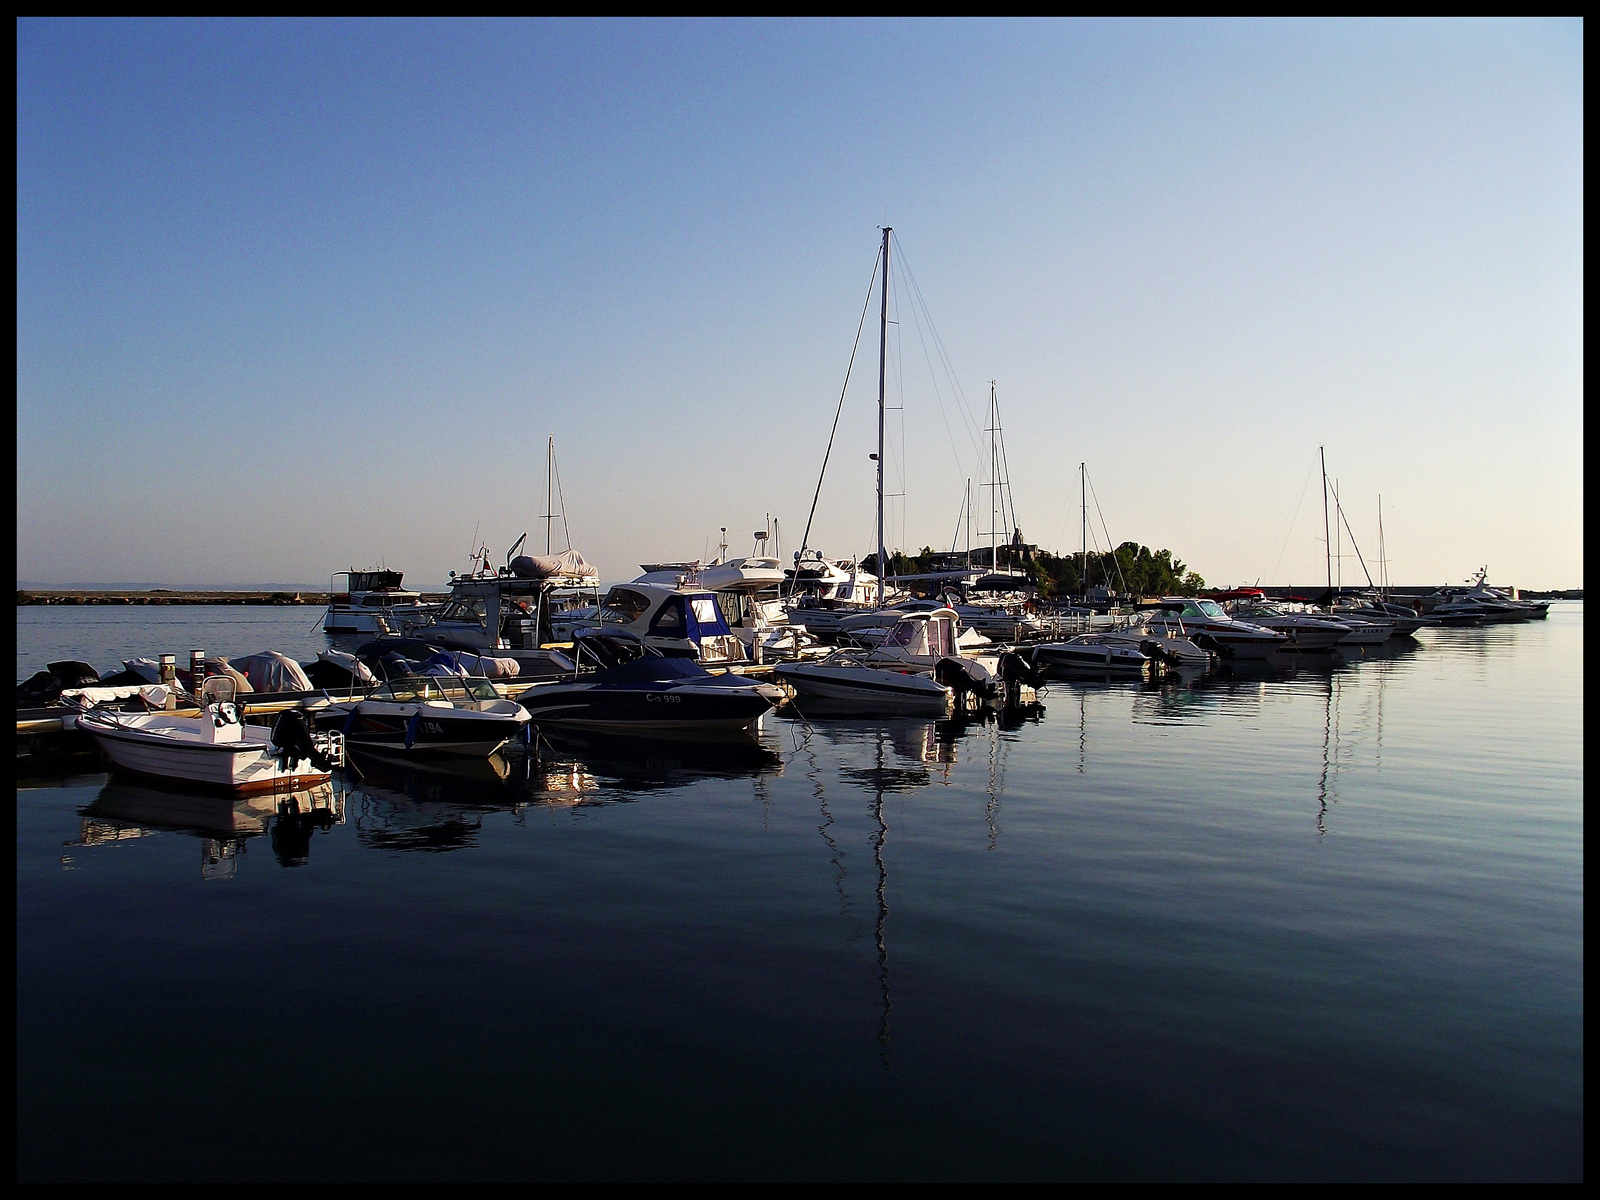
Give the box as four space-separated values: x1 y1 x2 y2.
18 603 1584 1179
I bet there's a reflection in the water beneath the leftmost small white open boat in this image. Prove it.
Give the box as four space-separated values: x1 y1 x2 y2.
61 776 344 880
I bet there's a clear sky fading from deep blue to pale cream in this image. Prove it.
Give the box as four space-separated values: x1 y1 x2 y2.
18 19 1582 589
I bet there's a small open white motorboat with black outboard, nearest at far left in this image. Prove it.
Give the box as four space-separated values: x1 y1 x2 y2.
77 675 342 794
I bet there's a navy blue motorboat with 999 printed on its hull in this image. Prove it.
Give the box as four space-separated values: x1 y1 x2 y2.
518 626 786 736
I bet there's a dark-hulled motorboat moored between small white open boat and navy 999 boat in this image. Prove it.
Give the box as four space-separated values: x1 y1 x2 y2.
314 675 528 758
